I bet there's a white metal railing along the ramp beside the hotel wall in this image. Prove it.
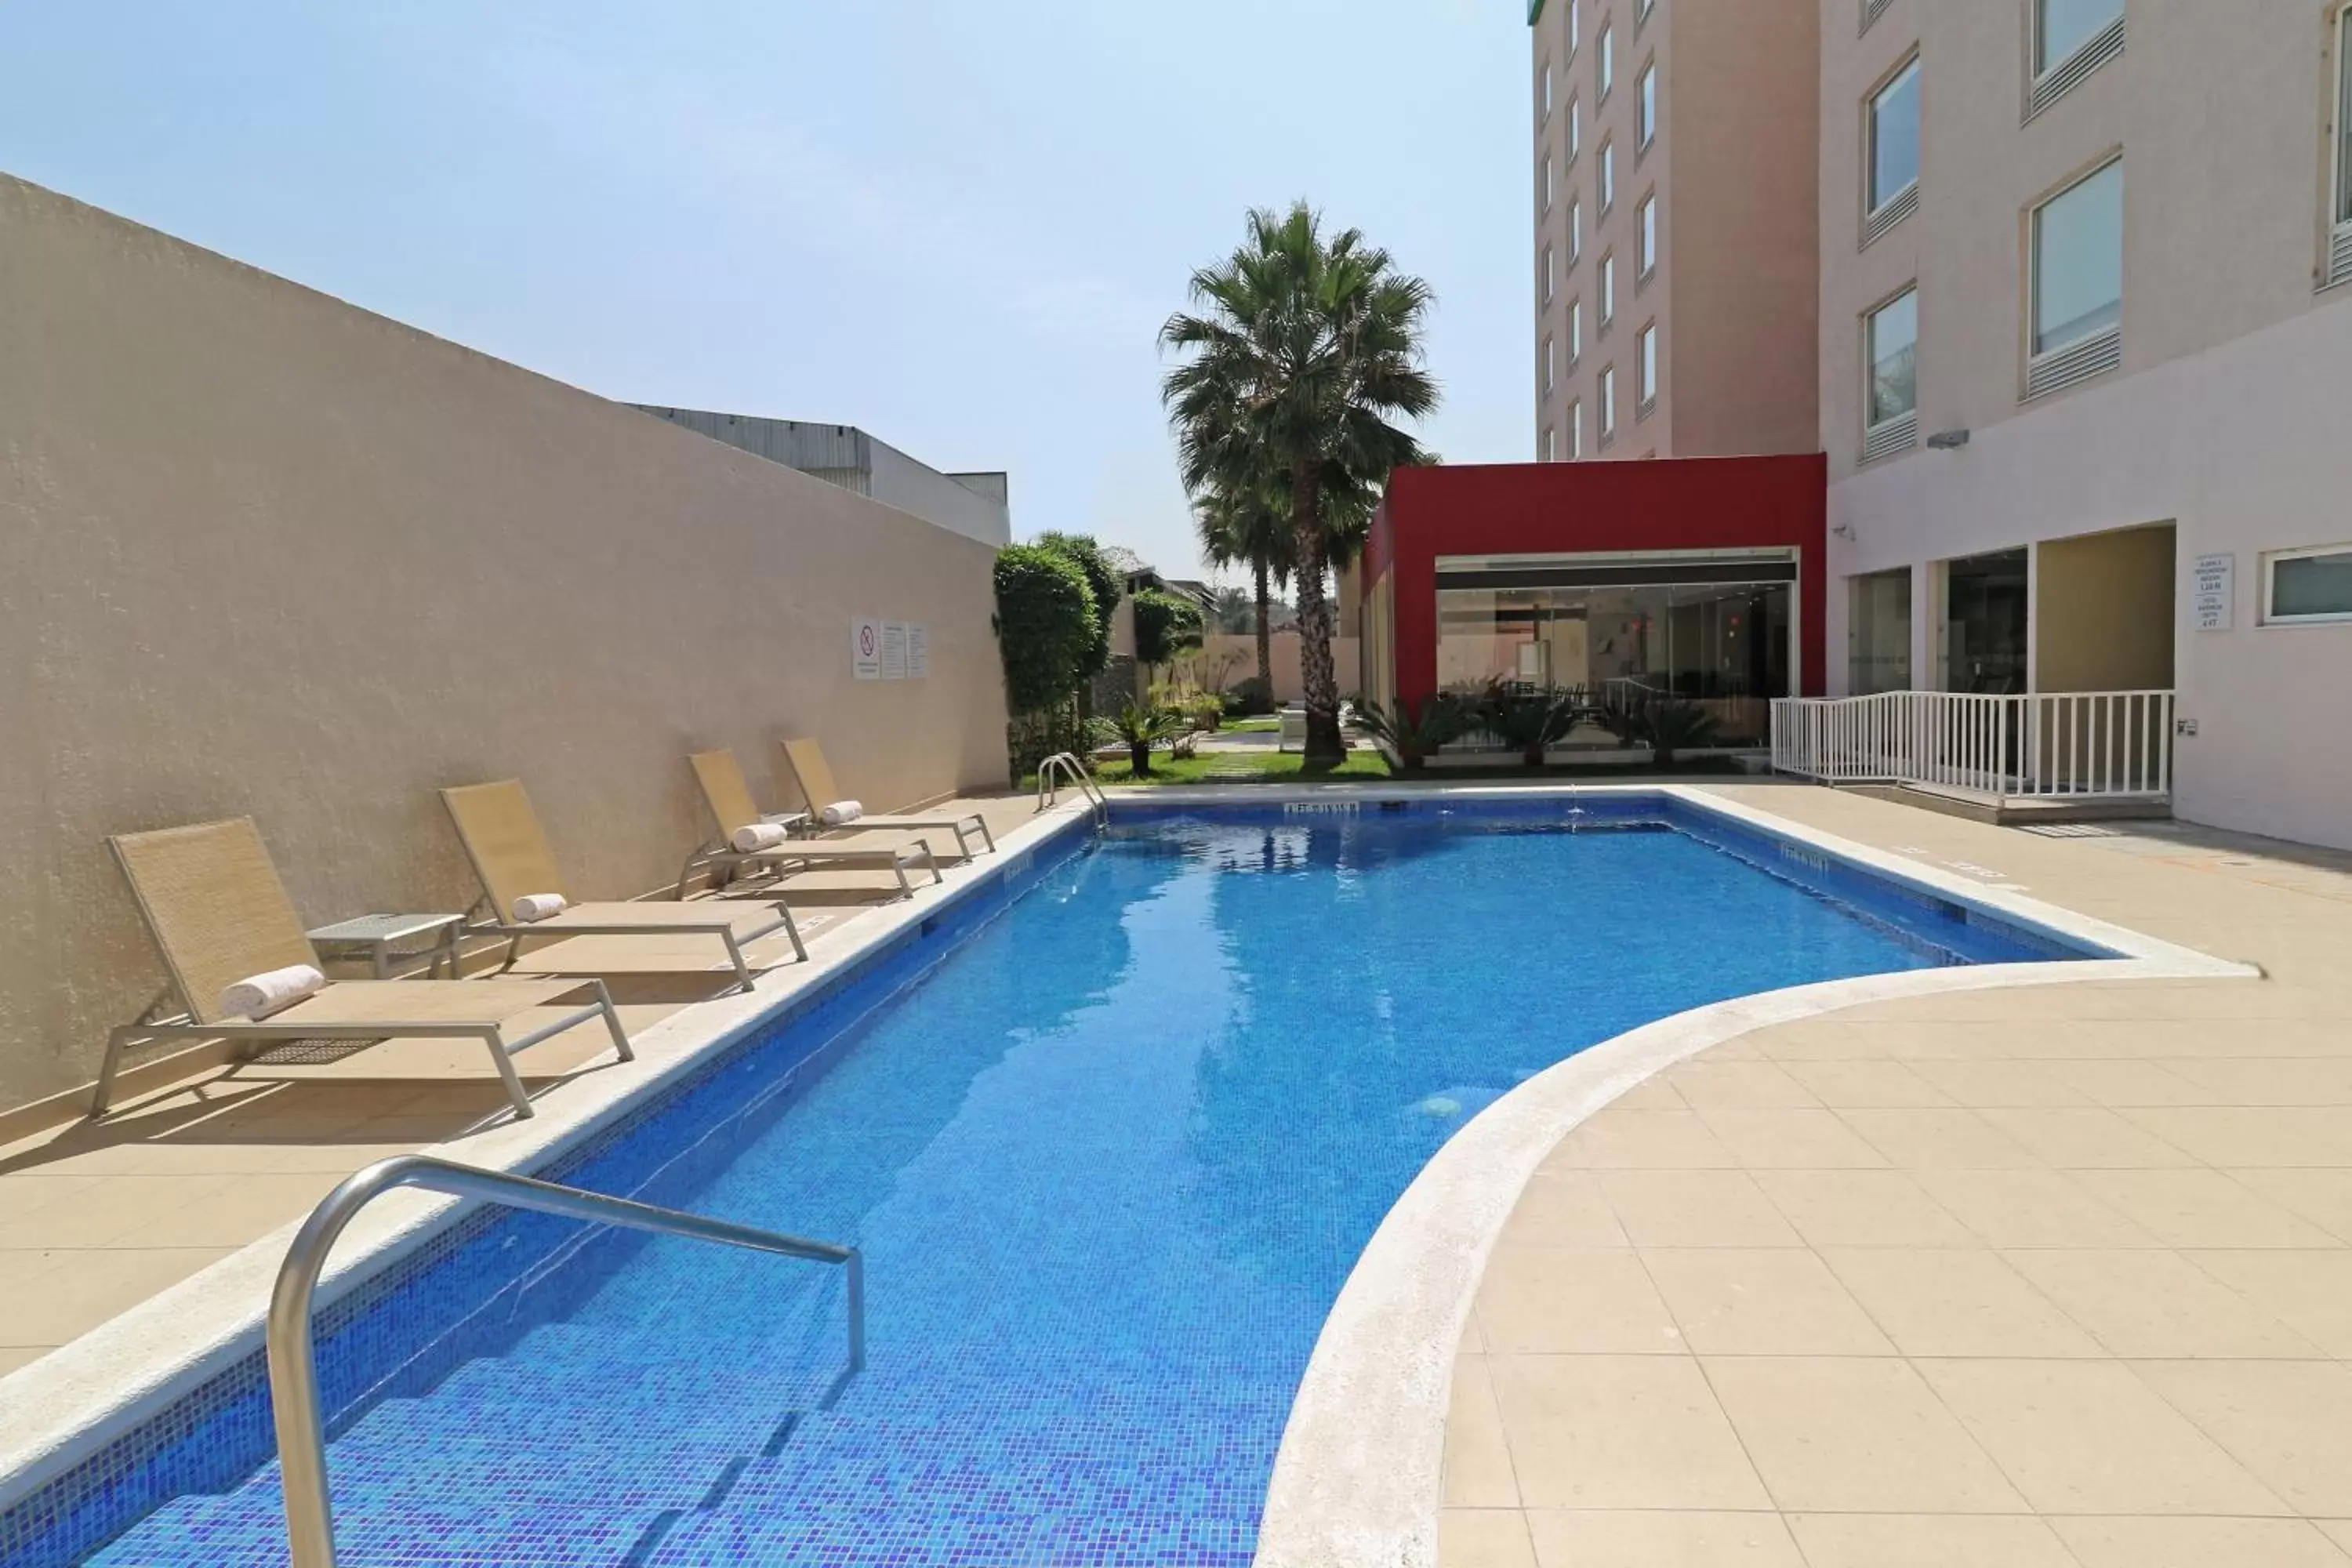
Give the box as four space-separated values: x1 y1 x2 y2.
1771 691 2173 801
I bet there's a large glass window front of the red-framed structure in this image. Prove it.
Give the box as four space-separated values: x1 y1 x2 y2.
1437 562 1792 750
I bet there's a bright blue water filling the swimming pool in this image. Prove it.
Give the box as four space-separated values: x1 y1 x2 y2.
92 811 2063 1568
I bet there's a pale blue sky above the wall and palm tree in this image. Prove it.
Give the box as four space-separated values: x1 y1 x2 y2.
0 0 1534 574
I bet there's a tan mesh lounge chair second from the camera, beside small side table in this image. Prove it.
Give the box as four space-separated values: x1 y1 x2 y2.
442 779 809 989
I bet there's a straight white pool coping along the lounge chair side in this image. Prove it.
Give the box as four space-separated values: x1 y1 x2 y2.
0 801 1087 1509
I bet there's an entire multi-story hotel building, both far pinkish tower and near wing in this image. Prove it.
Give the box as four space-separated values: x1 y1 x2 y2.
1534 0 2352 844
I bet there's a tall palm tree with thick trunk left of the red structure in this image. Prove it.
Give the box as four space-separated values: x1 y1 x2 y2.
1160 202 1437 762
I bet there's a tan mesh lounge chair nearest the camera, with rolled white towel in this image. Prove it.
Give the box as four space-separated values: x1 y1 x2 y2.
89 815 630 1116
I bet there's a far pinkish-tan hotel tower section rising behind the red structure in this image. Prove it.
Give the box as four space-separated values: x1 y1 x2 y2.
1529 0 1820 461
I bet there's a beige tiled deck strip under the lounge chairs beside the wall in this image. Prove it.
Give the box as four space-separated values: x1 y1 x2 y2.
0 794 1035 1375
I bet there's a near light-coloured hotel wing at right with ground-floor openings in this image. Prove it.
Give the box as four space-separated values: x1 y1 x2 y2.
1818 0 2352 844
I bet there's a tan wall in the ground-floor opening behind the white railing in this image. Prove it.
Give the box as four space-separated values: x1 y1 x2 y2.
2032 524 2173 691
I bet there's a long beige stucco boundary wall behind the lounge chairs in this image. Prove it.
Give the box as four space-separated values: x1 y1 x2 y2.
0 176 1004 1107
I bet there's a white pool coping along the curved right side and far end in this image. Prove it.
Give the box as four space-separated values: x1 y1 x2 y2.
1232 783 2260 1568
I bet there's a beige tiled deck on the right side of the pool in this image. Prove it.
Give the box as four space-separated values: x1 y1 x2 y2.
1439 785 2352 1568
